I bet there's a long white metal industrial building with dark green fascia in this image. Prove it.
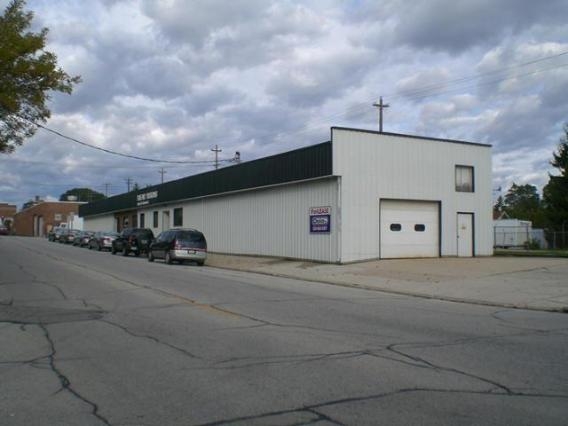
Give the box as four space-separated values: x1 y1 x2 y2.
79 127 493 263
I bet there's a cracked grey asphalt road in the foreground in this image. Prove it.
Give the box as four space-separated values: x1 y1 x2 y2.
0 237 568 426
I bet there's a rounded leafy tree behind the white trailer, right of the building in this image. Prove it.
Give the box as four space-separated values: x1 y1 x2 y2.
503 183 544 227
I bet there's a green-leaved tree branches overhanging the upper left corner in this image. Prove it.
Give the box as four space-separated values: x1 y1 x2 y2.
0 0 81 153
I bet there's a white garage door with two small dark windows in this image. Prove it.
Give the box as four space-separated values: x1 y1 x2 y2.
380 200 440 259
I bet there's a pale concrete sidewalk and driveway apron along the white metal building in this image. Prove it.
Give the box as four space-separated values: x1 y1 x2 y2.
207 253 568 312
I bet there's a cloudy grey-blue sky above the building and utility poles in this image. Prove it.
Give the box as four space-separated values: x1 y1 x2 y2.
0 0 568 207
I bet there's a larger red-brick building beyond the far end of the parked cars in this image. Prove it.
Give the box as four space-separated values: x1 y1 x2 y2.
14 201 84 237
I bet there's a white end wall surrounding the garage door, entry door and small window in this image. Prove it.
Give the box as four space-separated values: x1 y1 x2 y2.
332 129 493 262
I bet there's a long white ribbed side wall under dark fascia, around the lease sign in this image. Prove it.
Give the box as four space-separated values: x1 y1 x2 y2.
139 178 339 262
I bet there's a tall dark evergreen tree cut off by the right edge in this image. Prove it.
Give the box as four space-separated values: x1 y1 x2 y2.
542 123 568 231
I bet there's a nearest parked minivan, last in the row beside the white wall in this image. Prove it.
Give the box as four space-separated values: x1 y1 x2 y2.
148 228 207 266
